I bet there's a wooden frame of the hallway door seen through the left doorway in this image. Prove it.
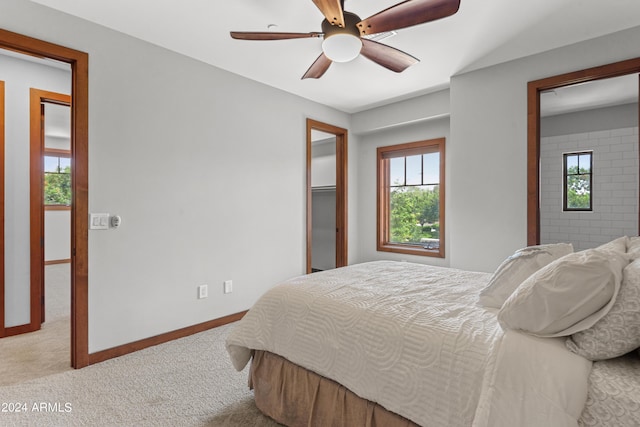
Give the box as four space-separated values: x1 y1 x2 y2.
29 88 73 331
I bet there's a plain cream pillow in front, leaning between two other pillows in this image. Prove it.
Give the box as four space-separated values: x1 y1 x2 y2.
498 249 628 337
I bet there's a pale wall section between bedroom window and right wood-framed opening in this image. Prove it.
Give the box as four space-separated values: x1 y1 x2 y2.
447 27 640 271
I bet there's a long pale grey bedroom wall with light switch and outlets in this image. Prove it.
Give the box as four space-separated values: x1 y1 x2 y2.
0 0 349 353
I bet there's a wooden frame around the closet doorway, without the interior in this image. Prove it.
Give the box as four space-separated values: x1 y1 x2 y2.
307 119 348 274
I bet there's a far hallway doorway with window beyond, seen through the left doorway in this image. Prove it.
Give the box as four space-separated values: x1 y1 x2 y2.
30 92 73 332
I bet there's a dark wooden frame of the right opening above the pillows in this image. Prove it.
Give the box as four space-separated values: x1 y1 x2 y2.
527 58 640 245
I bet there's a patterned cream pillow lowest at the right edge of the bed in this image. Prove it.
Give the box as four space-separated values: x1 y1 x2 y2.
566 259 640 360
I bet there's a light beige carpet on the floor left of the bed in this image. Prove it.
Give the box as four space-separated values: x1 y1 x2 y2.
0 266 278 427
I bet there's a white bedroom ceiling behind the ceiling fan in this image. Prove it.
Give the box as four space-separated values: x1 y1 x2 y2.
26 0 640 113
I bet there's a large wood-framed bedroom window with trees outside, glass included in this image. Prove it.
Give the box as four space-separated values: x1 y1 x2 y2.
377 138 445 258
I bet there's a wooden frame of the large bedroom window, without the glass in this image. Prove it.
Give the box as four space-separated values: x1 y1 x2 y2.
376 138 445 258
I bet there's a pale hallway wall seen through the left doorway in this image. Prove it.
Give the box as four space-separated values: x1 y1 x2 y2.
0 53 71 327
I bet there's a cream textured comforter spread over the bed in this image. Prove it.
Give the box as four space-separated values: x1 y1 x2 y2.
227 261 590 427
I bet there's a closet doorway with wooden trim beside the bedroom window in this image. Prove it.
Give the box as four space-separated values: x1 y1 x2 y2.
307 119 347 273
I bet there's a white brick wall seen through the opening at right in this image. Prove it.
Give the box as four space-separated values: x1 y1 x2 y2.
540 127 638 251
